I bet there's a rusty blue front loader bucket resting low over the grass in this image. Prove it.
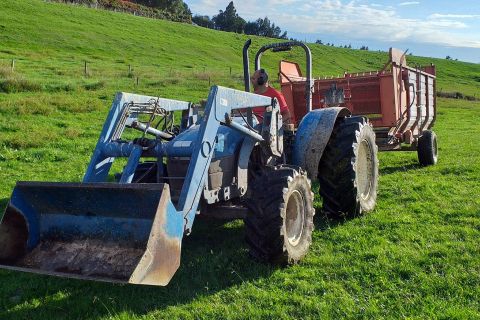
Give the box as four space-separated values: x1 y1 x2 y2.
0 182 184 285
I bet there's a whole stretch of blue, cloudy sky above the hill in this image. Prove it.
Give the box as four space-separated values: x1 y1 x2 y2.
185 0 480 63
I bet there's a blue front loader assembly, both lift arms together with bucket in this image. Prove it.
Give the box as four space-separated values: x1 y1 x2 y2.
0 86 276 285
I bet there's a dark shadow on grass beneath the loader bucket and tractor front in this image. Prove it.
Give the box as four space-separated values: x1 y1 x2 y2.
0 214 275 319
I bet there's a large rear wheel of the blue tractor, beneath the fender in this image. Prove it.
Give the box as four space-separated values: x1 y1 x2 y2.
318 116 378 215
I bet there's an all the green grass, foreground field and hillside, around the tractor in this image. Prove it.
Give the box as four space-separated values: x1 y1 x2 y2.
0 0 480 320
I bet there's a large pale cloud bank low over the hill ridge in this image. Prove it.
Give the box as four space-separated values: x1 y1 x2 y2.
189 0 480 48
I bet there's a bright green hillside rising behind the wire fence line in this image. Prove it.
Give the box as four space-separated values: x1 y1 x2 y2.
0 0 480 98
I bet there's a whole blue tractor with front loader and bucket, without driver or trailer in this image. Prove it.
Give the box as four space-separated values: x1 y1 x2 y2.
0 42 378 285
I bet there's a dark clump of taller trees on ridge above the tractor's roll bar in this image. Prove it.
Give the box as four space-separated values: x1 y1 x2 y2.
192 1 288 39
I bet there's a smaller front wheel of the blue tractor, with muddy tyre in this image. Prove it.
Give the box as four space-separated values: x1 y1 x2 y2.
245 166 315 264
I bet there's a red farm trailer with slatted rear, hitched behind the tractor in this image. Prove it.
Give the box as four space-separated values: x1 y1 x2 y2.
279 48 438 165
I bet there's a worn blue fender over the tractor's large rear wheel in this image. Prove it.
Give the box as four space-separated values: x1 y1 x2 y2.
292 107 351 181
